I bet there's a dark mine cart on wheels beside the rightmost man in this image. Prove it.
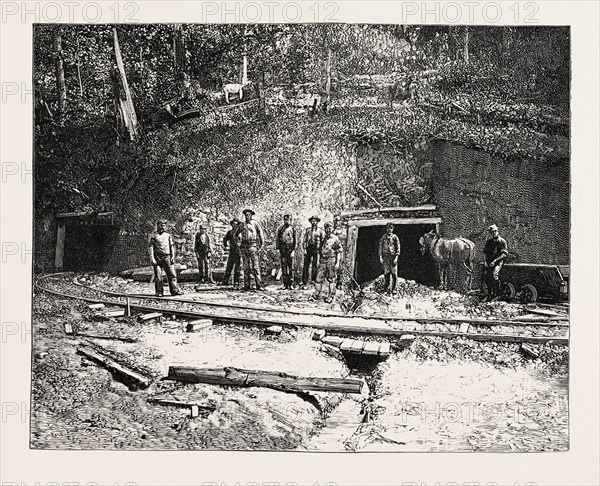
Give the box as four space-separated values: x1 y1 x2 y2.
500 263 570 303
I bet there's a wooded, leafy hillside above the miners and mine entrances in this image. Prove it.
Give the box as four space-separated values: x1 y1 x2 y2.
34 24 570 232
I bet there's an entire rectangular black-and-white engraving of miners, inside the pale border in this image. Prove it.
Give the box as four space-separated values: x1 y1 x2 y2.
30 23 571 453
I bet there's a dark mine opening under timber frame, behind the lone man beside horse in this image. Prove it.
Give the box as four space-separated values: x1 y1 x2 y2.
355 223 439 286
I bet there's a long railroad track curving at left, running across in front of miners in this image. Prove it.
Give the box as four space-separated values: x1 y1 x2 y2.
36 273 569 345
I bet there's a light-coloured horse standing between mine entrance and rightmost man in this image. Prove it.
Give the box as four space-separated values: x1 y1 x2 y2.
419 231 475 291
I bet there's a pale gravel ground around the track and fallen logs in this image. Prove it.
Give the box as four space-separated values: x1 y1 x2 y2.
31 276 568 452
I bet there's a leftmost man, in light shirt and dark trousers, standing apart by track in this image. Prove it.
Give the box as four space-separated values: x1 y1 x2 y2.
148 219 183 297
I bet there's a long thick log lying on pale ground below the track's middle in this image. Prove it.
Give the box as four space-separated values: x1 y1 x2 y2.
166 366 363 393
